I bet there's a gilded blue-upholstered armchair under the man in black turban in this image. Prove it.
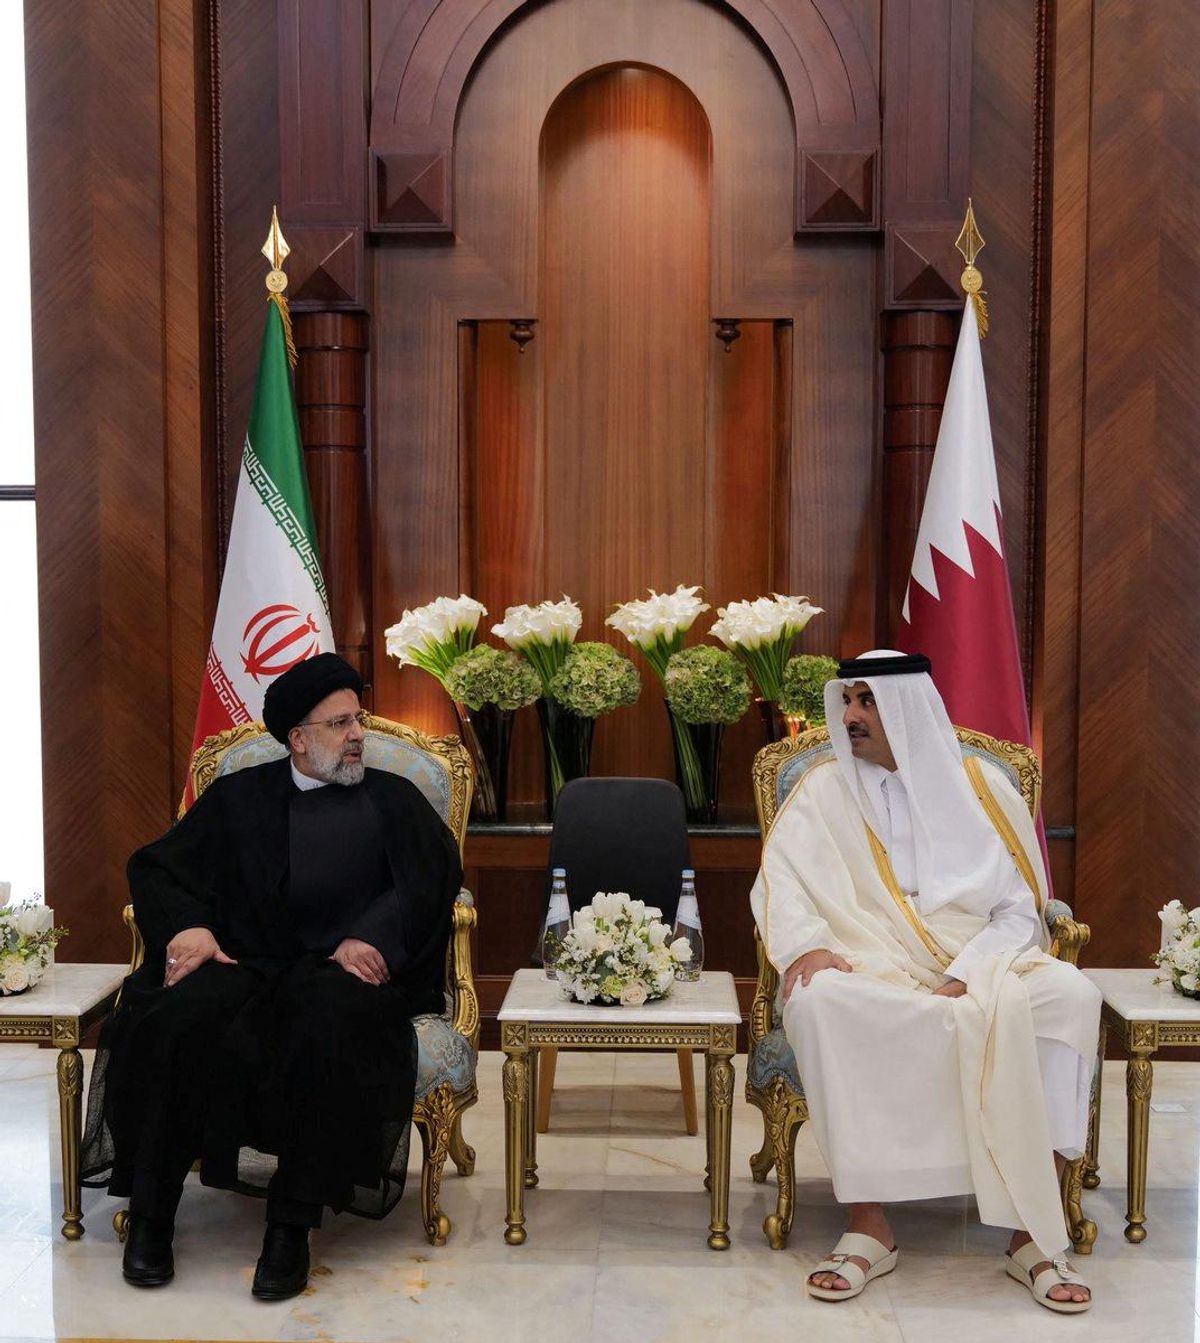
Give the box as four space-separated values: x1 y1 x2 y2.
113 716 479 1245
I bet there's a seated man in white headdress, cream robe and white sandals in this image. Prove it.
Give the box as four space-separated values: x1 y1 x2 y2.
752 650 1101 1313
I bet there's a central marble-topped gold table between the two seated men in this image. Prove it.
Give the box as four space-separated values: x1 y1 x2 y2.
498 970 742 1250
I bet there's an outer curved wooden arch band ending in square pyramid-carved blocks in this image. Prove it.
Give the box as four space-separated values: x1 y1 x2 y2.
369 0 879 235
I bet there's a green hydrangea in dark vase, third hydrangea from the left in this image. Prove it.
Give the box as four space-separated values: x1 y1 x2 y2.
663 643 752 823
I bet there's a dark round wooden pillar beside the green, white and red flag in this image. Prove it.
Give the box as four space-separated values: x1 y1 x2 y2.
293 312 372 702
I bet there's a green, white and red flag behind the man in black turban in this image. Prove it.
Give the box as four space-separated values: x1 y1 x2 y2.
184 297 334 807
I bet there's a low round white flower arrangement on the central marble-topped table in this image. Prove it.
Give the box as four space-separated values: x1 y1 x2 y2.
554 890 691 1007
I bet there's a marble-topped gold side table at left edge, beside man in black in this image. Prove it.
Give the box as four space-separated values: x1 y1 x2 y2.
0 964 129 1241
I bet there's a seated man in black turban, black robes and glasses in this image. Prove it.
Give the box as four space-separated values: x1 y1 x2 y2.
82 653 462 1299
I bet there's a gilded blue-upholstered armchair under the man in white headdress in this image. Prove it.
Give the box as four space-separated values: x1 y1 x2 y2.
746 728 1095 1254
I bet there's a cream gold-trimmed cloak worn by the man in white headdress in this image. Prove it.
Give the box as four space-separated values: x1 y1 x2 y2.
752 761 1099 1254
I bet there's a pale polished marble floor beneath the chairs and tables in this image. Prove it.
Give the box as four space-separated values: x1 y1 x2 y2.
0 1045 1200 1343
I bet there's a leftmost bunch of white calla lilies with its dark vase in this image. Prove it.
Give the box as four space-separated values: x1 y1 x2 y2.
384 594 511 821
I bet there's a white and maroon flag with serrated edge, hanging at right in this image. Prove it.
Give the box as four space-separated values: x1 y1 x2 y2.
897 298 1031 745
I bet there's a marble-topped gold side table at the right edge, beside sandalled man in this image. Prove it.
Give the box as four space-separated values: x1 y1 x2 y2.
1083 970 1200 1244
